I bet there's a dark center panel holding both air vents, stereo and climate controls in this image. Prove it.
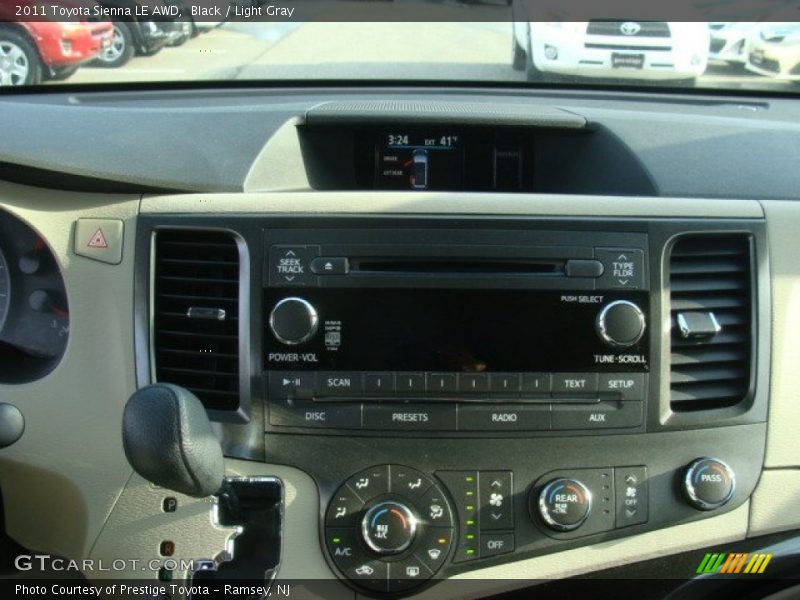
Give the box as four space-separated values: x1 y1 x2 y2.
138 215 769 595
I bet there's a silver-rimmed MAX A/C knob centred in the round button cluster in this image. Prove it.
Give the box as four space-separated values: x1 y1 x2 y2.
361 501 417 556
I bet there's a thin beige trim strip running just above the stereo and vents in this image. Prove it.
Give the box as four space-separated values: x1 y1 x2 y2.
141 192 764 218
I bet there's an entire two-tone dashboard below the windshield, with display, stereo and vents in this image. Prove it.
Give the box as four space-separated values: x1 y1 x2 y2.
0 87 800 598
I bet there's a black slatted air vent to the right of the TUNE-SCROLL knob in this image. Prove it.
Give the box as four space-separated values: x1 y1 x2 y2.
669 234 753 412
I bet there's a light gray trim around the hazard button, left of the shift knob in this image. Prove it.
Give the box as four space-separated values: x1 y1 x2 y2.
0 184 138 557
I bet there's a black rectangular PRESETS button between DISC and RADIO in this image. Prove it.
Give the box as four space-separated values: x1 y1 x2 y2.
364 404 457 431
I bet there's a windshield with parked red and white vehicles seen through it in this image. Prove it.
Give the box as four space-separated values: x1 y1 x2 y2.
0 0 800 93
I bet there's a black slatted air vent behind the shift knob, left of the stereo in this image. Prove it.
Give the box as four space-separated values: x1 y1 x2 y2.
153 230 239 410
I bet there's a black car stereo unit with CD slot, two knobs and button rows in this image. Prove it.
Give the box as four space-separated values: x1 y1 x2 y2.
263 230 650 433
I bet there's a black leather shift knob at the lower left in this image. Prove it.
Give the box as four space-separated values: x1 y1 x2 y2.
122 383 225 498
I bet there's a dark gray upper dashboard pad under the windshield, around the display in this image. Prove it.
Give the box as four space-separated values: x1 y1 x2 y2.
0 88 800 199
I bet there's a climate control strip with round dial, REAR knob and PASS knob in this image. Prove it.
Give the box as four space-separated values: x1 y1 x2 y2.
324 457 734 594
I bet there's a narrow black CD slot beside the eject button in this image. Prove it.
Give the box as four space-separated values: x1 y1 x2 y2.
350 257 566 277
